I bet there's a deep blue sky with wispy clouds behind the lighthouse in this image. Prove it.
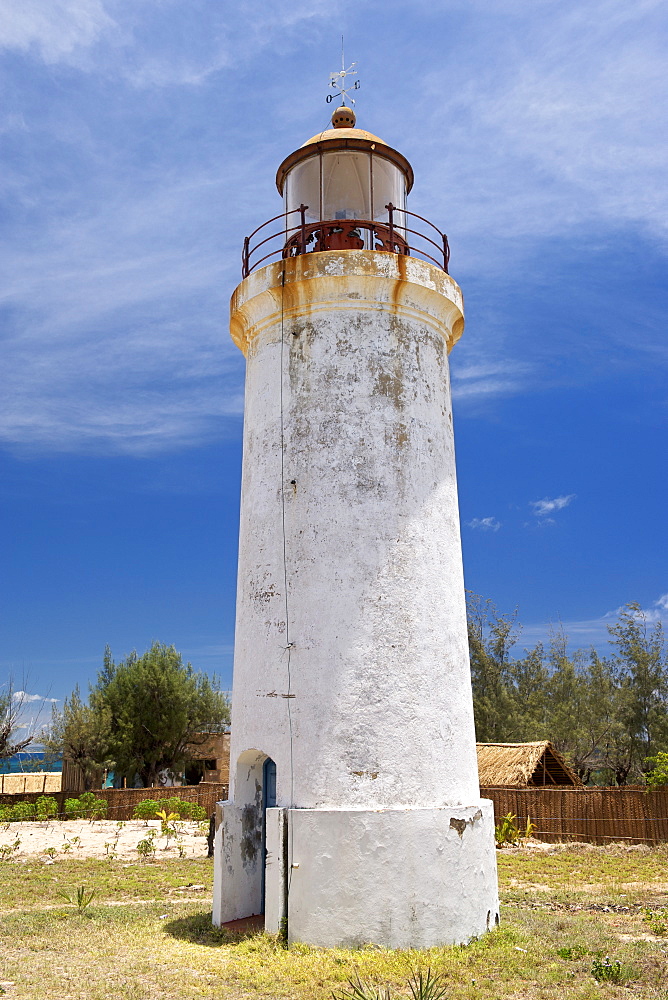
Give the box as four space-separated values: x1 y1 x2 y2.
0 0 668 712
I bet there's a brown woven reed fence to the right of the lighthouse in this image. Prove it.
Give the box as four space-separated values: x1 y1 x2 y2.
480 786 668 844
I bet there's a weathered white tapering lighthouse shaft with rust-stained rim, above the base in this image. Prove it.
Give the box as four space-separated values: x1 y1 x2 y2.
230 251 479 808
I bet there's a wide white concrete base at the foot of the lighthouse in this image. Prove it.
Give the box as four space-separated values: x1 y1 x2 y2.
214 799 499 948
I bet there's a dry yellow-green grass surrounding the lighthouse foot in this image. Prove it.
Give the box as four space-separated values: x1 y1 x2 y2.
0 848 668 1000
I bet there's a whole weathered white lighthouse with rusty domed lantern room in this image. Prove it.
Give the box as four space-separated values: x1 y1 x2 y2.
213 99 499 948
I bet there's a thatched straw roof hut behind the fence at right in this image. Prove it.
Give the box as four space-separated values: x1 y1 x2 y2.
476 740 582 788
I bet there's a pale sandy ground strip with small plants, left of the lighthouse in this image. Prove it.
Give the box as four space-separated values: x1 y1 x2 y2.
0 819 208 864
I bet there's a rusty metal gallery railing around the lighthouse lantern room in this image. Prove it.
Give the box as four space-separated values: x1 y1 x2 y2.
241 203 450 278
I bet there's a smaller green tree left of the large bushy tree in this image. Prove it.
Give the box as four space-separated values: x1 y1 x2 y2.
44 685 111 791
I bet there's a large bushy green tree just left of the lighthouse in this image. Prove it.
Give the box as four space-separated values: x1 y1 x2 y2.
90 642 230 785
